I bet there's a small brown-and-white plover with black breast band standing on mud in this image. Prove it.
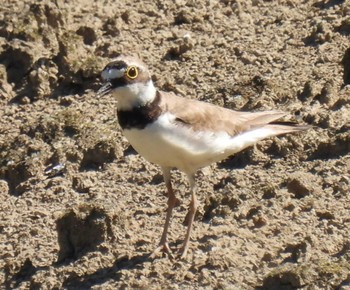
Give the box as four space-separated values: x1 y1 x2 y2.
96 55 310 258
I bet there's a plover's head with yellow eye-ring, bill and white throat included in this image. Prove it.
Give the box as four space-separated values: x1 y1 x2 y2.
97 56 156 110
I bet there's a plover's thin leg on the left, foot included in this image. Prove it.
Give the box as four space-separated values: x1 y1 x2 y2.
151 168 179 258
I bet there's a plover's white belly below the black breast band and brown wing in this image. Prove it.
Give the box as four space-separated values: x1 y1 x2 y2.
124 113 274 174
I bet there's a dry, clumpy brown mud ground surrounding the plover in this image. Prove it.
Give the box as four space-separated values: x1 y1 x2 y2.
0 0 350 290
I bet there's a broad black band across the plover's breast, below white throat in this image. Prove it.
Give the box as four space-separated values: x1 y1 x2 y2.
117 92 161 130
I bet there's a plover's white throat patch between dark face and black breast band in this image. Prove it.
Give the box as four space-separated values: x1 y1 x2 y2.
113 80 156 110
